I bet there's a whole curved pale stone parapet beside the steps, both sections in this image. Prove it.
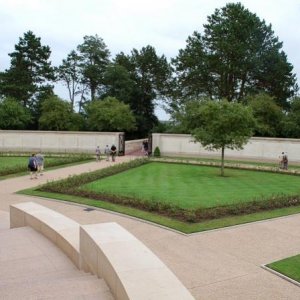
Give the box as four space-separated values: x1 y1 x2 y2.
10 202 194 300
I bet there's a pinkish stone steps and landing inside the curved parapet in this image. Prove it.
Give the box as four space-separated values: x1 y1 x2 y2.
0 227 113 300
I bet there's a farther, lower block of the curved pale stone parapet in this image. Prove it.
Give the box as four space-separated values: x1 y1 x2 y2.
10 202 81 268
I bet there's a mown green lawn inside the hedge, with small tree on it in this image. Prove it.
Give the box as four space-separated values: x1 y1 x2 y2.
81 162 300 209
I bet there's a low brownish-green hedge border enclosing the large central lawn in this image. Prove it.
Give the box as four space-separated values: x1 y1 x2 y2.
38 158 300 223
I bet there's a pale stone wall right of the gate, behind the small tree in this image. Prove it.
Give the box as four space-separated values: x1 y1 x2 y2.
152 133 300 162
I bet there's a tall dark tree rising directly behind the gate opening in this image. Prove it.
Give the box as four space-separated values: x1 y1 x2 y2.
115 46 171 136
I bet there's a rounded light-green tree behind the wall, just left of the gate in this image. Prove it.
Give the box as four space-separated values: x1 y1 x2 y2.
85 97 136 132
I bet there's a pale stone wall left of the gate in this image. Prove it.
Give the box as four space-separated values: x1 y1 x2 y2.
0 130 122 153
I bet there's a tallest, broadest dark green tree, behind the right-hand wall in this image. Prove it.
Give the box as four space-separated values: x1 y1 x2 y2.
173 3 297 107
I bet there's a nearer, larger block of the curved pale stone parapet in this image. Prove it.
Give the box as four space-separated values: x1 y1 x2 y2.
80 223 194 300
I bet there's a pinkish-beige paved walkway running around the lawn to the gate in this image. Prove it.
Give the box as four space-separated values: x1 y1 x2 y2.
0 156 300 300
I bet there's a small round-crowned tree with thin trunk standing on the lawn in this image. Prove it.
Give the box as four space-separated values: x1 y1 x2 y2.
183 100 255 176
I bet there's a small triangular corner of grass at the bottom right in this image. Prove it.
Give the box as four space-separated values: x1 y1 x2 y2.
267 254 300 282
